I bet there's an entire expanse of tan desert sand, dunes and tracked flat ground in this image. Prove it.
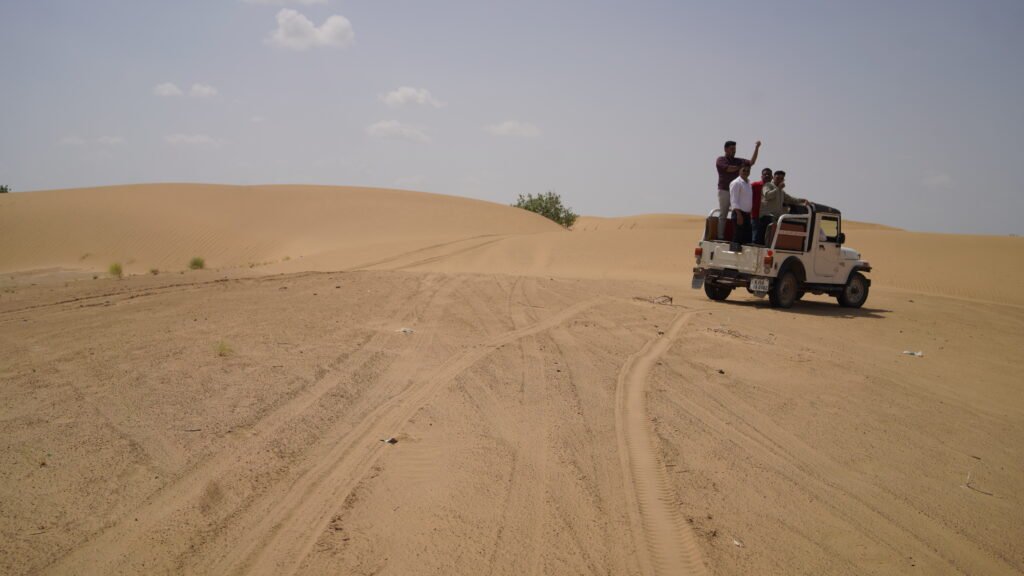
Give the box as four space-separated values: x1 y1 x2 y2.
0 184 1024 575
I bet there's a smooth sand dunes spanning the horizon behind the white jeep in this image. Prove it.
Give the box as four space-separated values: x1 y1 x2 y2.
6 184 1024 305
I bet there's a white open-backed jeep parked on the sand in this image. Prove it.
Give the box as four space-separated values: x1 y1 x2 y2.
692 204 871 308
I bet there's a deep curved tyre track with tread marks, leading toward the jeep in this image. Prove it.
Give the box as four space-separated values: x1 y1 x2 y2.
615 311 707 576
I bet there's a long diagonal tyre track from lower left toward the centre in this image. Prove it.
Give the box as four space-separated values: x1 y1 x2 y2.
209 297 602 575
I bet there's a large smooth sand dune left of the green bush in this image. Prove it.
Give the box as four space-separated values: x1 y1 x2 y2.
0 183 561 273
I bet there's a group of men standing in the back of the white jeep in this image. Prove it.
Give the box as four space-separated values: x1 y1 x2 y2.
715 140 809 247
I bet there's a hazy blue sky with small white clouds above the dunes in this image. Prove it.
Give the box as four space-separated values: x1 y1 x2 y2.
0 0 1024 235
